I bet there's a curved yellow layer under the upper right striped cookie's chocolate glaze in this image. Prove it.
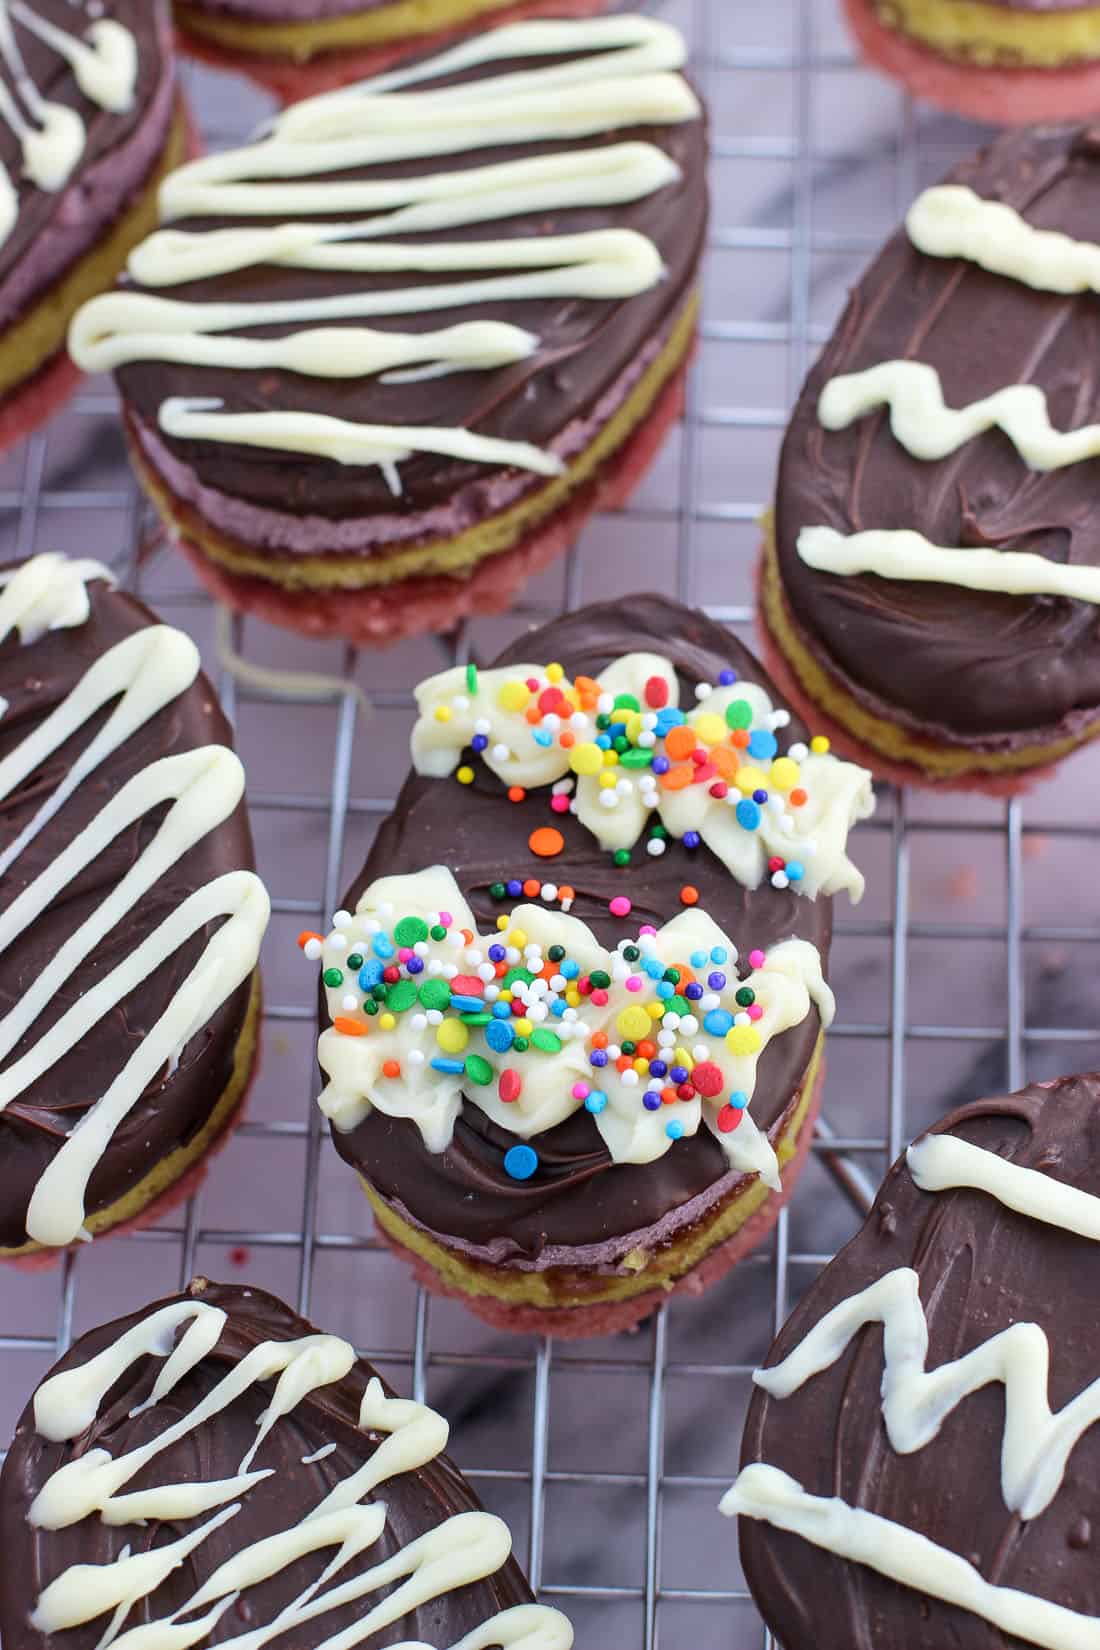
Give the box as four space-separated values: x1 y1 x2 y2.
760 525 1100 780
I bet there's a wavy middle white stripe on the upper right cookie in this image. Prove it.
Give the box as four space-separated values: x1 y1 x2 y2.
818 361 1100 470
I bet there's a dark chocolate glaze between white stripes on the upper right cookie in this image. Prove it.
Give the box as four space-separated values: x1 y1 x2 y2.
777 129 1100 747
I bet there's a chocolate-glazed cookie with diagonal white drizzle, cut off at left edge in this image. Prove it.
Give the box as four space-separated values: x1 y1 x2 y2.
0 556 267 1256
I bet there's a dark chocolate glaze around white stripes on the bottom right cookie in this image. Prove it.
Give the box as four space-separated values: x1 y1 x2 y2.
740 1073 1100 1650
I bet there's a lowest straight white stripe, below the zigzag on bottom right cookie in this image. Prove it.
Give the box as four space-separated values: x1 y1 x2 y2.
721 1462 1100 1650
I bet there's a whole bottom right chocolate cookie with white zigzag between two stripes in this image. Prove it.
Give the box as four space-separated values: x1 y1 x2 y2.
724 1073 1100 1650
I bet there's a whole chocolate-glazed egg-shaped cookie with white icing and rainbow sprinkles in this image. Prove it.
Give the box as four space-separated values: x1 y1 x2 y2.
307 597 871 1333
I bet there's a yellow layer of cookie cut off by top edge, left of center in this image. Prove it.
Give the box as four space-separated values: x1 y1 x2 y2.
175 0 540 63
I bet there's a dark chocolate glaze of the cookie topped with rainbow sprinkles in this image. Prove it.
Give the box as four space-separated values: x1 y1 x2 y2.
331 596 833 1261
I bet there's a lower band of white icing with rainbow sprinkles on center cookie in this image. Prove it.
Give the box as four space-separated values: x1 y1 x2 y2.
313 866 833 1188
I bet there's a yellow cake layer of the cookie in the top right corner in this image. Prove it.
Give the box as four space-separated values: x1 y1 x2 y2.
872 0 1100 69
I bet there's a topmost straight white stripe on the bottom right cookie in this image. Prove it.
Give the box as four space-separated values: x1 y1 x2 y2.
905 1134 1100 1242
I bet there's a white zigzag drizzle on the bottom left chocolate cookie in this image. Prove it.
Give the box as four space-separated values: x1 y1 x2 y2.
30 1300 572 1650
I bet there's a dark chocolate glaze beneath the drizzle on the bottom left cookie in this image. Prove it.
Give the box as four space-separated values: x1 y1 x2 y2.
0 1279 531 1650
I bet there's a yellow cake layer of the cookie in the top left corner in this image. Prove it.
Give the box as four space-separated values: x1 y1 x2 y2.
0 111 188 396
